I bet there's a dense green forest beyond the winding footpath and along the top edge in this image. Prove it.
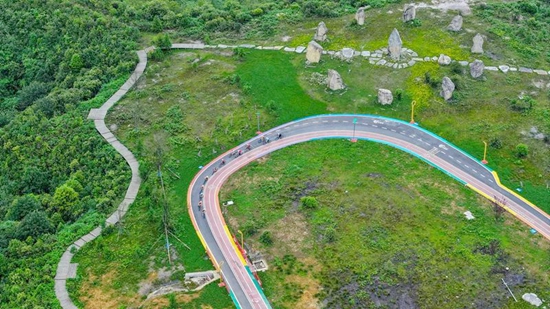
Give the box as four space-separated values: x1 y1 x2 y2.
0 0 550 308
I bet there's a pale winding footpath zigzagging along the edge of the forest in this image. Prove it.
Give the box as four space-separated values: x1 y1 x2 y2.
55 48 152 309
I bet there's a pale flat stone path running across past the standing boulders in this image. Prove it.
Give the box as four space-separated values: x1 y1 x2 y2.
172 43 550 75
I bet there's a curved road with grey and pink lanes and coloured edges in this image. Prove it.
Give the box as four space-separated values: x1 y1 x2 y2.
187 115 550 308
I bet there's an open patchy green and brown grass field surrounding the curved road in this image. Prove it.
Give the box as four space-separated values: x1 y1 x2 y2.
70 3 550 308
